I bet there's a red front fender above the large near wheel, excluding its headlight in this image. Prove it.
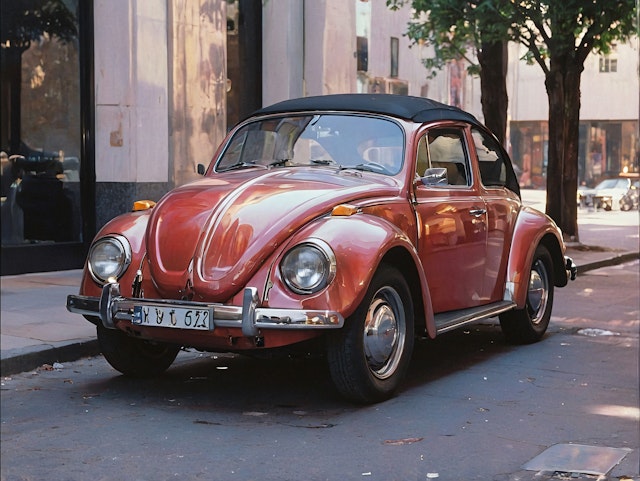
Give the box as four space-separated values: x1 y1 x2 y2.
265 214 435 337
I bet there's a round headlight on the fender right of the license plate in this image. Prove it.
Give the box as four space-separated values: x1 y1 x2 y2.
280 239 336 294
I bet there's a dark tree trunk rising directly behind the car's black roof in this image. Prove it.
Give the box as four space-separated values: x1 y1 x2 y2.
478 42 509 145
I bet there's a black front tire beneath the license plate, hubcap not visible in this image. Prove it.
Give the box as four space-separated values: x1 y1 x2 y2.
97 325 180 378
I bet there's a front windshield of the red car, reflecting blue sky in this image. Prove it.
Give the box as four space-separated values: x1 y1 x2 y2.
215 114 404 175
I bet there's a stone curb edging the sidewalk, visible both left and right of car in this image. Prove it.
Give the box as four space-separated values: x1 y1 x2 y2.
0 252 640 377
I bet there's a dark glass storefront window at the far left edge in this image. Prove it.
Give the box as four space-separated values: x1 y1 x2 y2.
0 0 92 274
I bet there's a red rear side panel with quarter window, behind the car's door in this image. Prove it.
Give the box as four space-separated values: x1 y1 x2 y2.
471 127 519 302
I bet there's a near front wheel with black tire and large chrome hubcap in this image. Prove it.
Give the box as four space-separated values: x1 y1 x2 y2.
327 265 414 404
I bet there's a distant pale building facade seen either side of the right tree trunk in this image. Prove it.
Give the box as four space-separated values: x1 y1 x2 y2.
507 37 640 188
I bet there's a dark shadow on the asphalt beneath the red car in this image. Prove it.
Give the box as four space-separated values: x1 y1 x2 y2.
76 318 514 412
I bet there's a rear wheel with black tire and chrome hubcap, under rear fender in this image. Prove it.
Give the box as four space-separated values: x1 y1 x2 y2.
500 245 554 344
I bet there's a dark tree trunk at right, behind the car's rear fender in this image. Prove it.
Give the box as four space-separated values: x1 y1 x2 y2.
545 57 583 242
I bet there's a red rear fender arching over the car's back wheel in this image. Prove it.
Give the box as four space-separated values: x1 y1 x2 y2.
504 207 567 309
